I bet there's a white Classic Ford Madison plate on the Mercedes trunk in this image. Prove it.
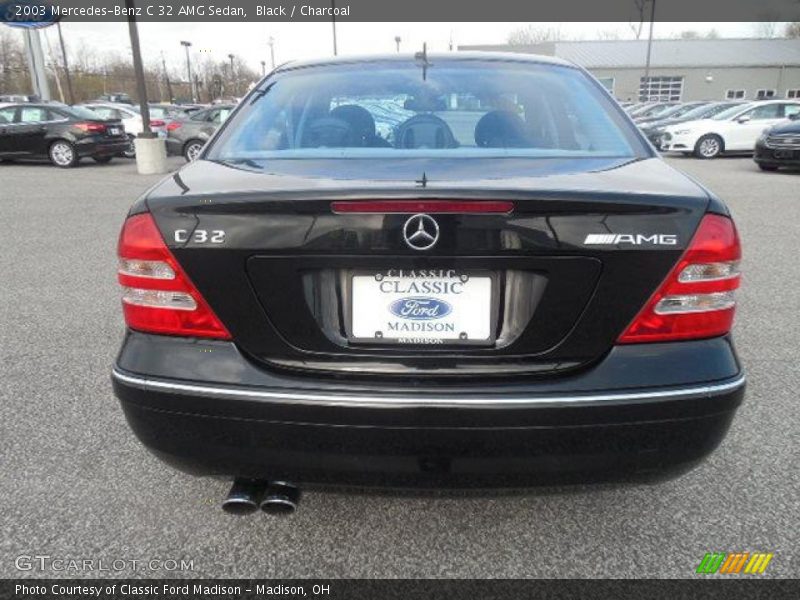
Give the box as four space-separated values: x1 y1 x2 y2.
350 269 494 345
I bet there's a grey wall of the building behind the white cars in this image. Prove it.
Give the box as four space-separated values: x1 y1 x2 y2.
589 66 800 101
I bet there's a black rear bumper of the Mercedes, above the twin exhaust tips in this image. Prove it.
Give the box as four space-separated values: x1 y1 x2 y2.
112 333 744 487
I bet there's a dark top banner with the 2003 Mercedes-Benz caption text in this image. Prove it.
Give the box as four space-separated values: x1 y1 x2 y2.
0 0 800 26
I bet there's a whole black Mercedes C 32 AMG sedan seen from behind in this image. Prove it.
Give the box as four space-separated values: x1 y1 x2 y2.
113 54 744 511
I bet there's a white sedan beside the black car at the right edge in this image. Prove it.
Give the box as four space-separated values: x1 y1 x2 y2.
661 100 800 158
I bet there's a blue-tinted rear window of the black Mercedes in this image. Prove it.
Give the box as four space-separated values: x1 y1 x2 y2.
206 59 637 160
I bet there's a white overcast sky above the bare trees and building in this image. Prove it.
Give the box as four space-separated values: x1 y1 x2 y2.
36 21 782 70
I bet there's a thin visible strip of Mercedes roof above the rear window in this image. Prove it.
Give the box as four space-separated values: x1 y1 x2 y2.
276 51 576 72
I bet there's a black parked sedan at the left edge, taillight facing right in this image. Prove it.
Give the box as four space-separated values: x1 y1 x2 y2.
0 104 128 167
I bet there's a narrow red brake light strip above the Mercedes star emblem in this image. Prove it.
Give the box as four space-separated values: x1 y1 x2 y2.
331 200 514 215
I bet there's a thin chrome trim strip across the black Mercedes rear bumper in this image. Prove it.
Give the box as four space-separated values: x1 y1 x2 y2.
112 368 746 409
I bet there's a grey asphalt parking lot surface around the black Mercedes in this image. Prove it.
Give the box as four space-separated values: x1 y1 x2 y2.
0 158 800 578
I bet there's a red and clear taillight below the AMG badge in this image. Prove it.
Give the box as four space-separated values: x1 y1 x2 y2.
618 215 742 344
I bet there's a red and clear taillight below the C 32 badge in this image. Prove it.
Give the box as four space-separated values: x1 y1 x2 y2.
117 213 231 339
